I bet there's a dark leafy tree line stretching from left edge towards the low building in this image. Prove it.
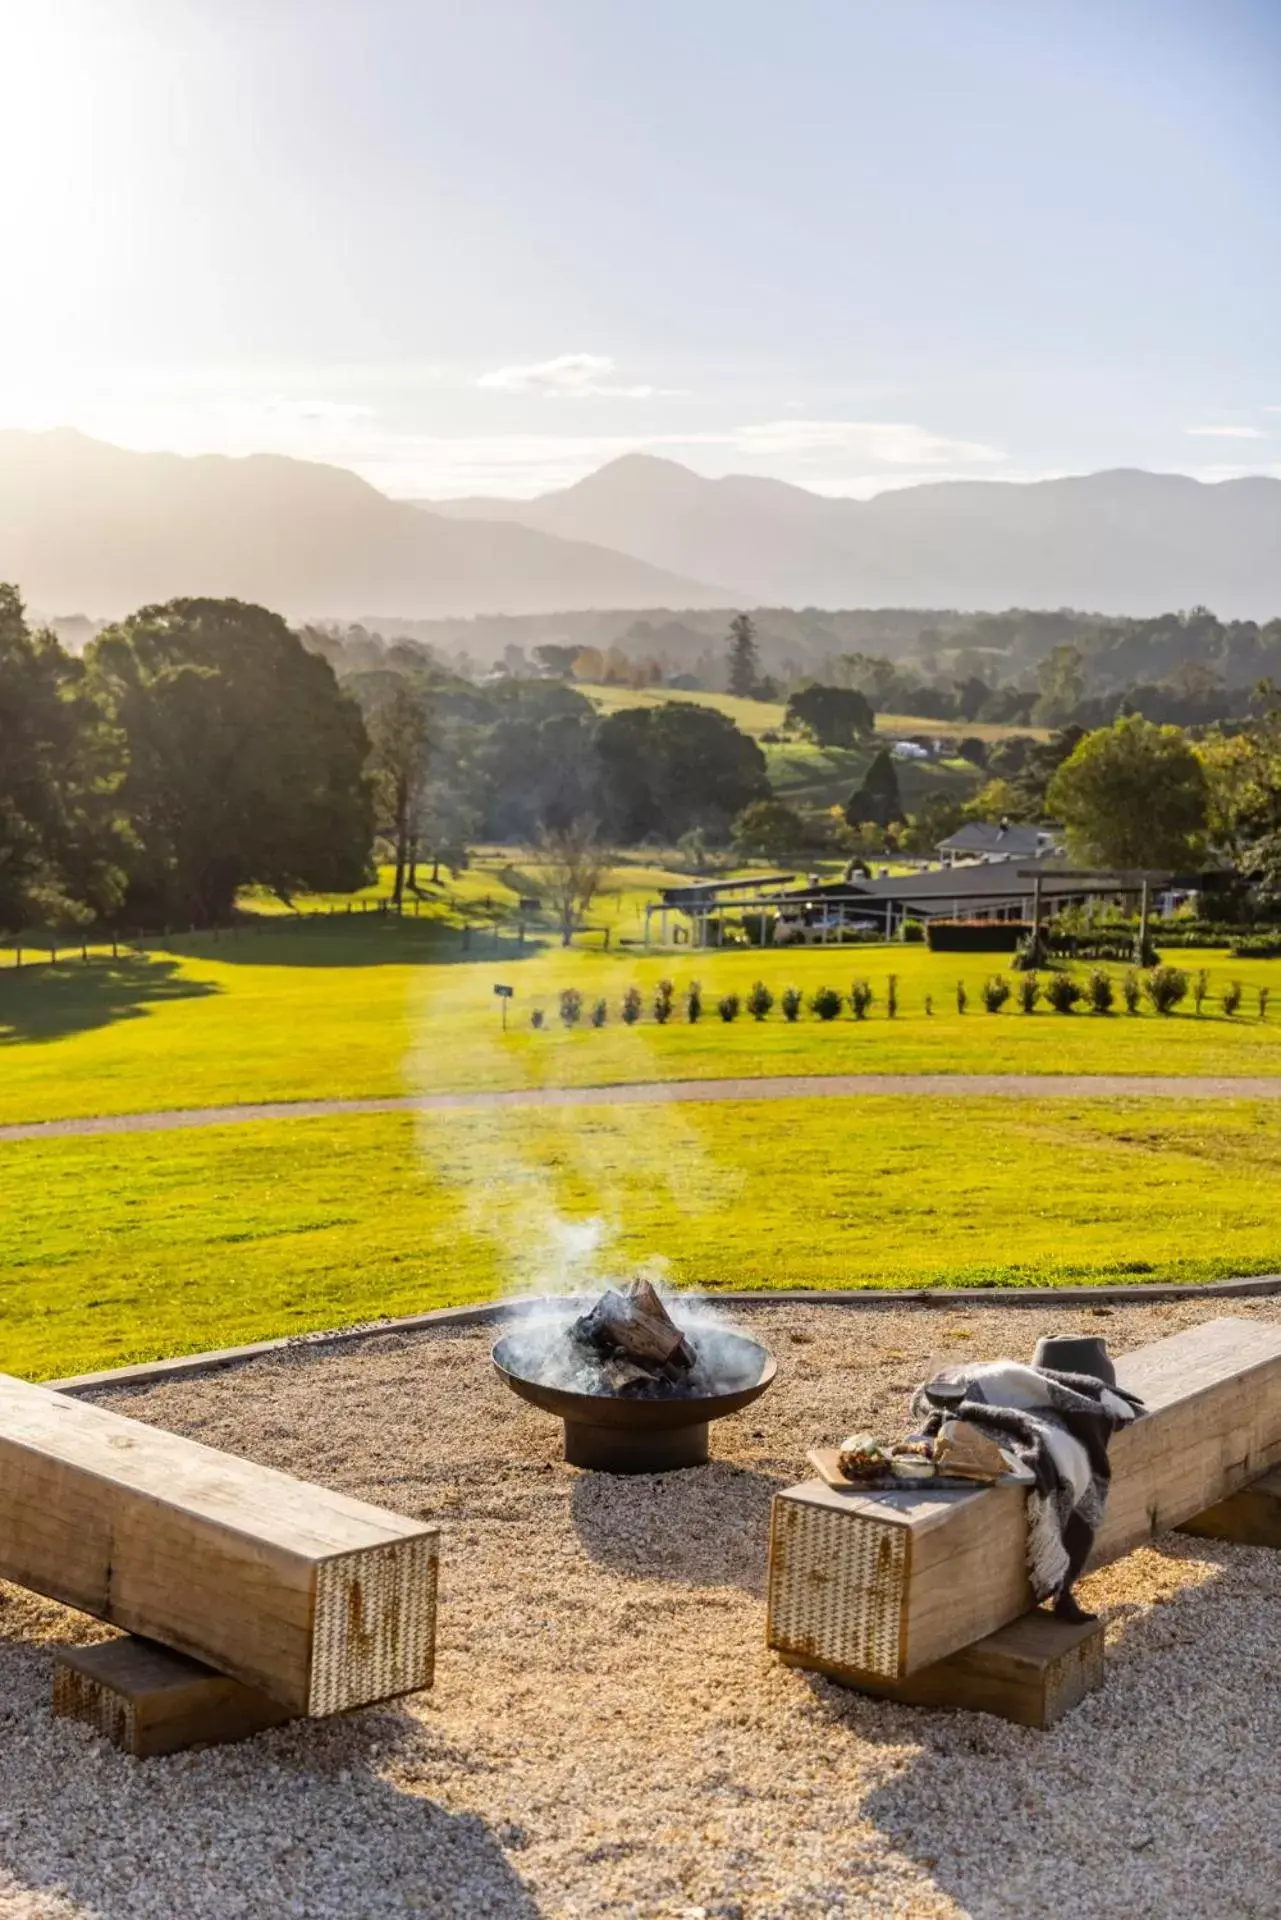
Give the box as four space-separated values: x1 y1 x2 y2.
0 586 770 931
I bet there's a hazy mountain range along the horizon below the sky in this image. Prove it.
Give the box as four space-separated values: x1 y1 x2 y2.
0 428 1281 620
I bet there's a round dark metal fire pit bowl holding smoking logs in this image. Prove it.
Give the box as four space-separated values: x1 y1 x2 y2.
494 1319 778 1473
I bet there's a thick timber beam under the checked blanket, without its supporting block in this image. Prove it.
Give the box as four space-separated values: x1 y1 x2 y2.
768 1319 1281 1682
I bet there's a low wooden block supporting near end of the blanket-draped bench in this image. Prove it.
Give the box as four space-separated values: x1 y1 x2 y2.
782 1609 1104 1728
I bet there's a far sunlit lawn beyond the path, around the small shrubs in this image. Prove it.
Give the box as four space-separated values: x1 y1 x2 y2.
0 918 1281 1121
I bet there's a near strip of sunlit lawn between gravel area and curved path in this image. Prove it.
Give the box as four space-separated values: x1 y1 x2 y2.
0 1096 1281 1377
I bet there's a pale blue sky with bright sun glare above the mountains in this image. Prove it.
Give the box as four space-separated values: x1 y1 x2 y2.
0 0 1281 499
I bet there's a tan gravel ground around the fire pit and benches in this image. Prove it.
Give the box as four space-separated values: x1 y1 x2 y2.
0 1302 1281 1920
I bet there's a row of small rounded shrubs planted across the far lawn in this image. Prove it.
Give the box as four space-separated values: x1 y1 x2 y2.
530 966 1271 1027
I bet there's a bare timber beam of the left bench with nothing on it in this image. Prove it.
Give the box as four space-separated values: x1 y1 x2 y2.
0 1375 440 1738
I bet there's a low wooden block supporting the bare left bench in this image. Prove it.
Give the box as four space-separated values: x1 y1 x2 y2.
54 1636 296 1759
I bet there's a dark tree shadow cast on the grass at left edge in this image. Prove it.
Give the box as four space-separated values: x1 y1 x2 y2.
0 954 221 1046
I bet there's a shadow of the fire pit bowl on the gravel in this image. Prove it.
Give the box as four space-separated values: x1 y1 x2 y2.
570 1451 795 1596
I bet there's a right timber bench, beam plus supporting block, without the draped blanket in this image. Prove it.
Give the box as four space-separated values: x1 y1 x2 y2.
766 1319 1281 1726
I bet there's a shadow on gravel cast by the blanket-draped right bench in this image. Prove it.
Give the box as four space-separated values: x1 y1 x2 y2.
807 1540 1281 1920
